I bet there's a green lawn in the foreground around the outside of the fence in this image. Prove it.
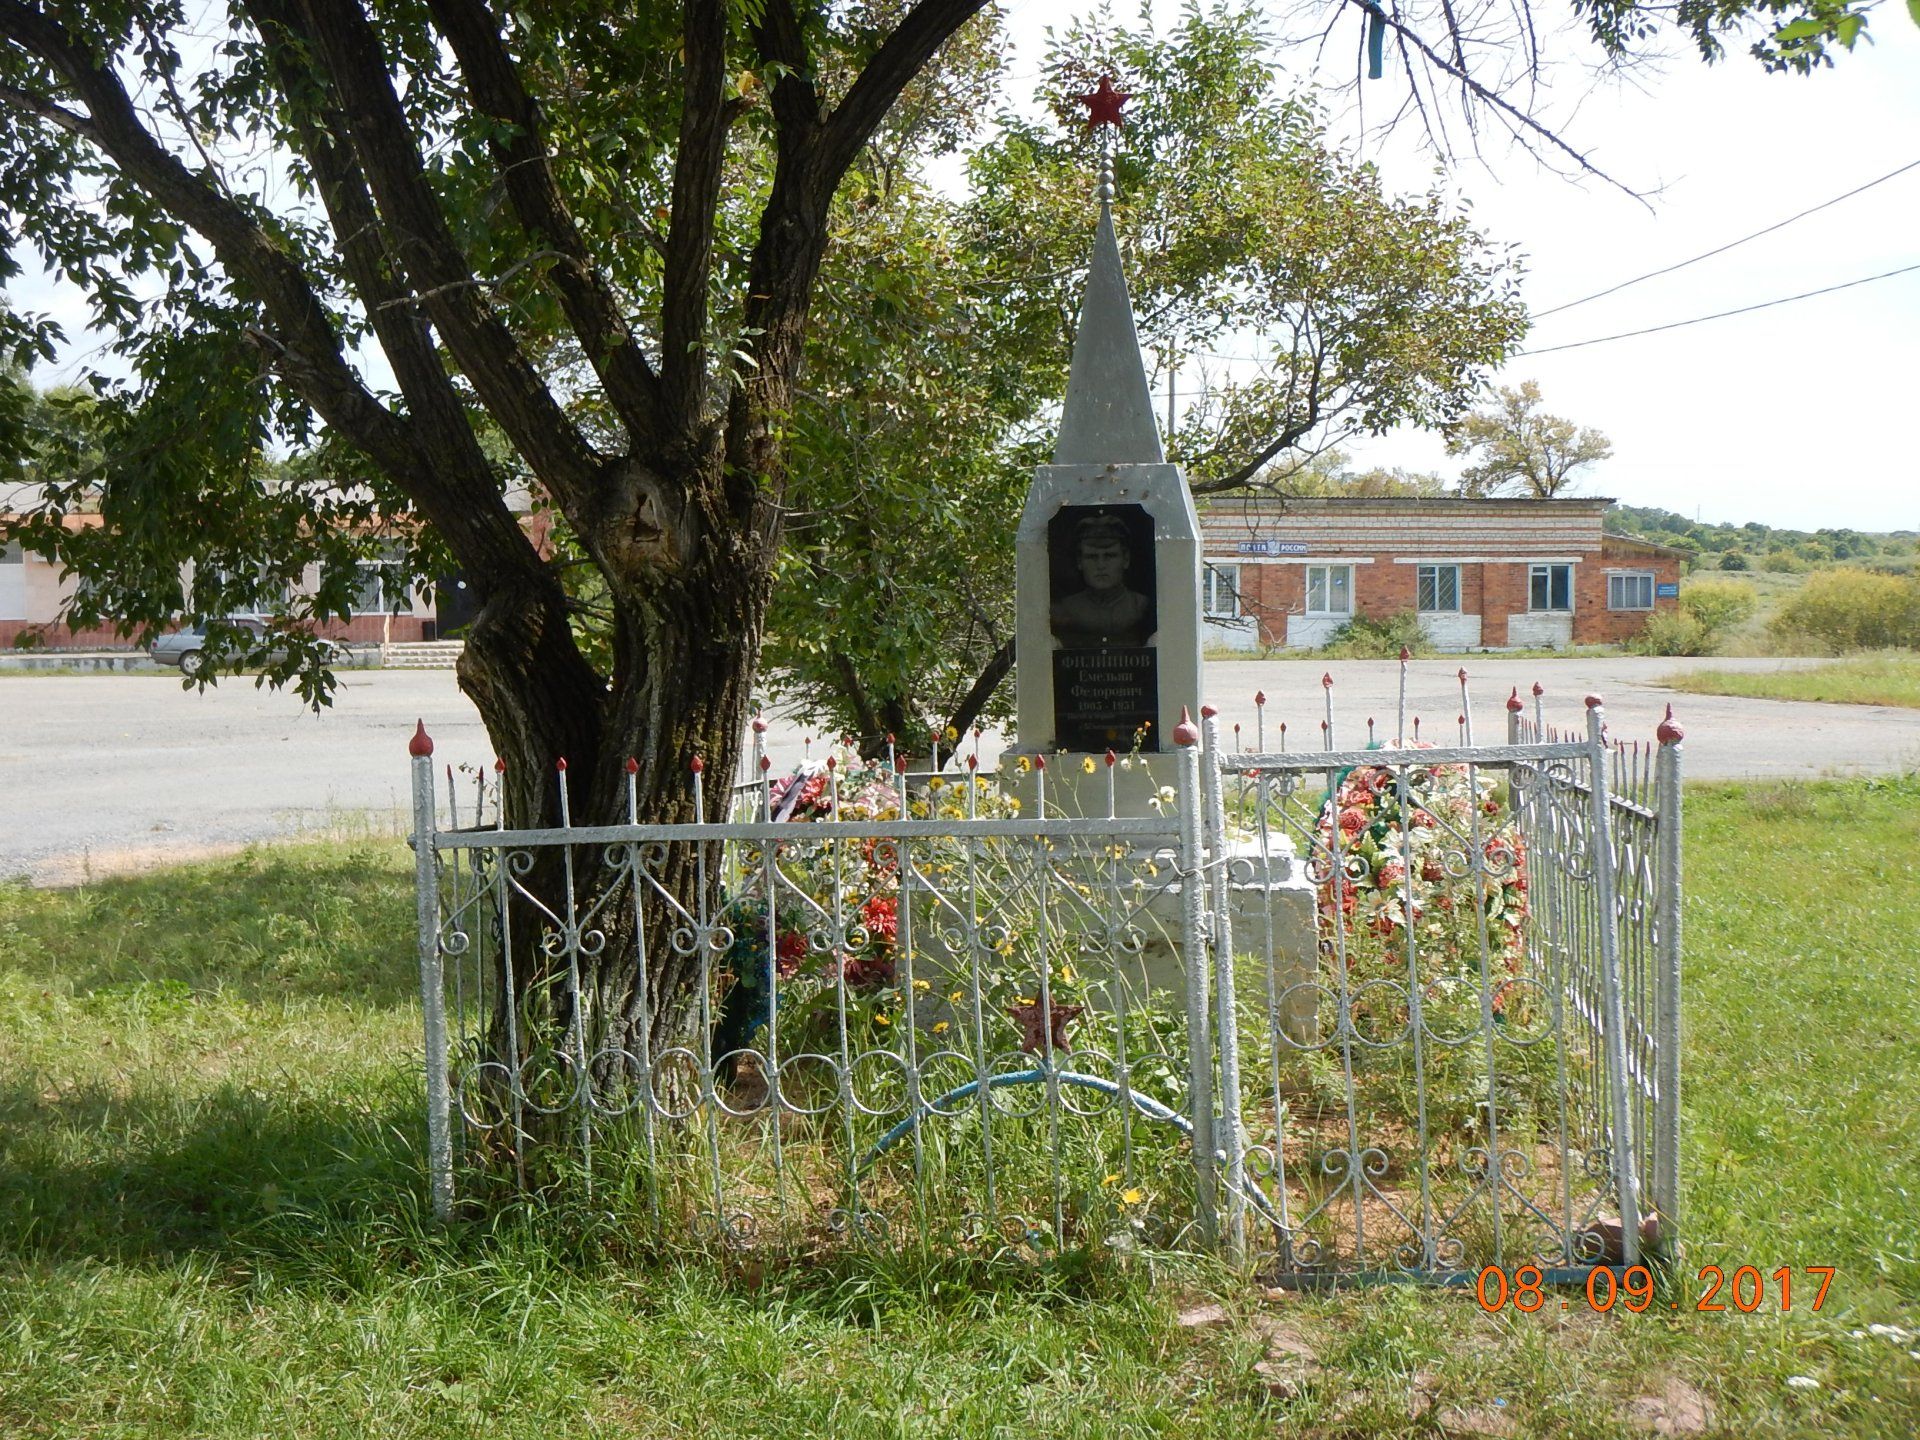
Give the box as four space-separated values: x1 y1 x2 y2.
0 802 1920 1440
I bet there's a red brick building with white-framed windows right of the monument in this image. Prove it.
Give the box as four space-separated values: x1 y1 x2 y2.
1200 495 1686 651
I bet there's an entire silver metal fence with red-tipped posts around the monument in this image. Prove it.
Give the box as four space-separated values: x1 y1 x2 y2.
413 682 1678 1283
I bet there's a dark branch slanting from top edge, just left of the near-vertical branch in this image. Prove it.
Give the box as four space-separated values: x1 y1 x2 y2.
428 0 660 434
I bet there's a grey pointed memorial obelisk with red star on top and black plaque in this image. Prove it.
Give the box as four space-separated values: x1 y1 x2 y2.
1014 79 1202 812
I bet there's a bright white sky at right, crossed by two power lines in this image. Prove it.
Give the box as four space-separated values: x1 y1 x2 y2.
1008 0 1920 530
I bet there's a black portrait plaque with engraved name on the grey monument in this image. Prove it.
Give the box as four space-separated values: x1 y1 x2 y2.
1046 505 1160 751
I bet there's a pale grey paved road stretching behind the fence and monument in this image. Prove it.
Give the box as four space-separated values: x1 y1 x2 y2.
0 655 1920 883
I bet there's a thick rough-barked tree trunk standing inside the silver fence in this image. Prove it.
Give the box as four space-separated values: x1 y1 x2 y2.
459 480 772 1083
